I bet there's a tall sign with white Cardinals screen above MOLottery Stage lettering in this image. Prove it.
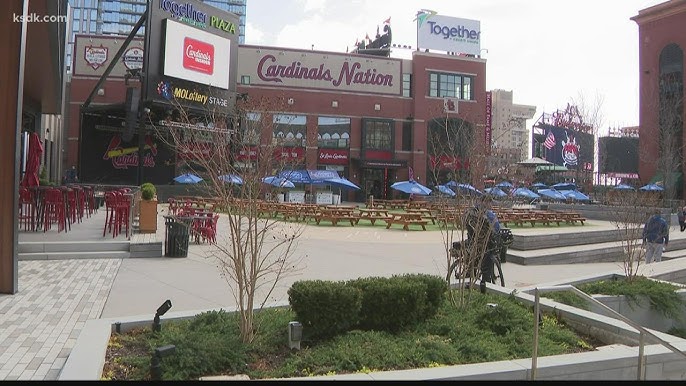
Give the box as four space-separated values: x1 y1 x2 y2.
145 0 239 111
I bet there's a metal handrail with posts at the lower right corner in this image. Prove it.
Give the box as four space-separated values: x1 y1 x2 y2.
531 284 686 381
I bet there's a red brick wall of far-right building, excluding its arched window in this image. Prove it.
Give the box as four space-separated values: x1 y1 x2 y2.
632 0 686 191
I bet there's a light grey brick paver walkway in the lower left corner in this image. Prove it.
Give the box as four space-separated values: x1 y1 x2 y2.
0 259 121 380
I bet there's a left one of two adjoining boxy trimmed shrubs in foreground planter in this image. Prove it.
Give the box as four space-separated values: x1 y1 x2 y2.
288 280 362 339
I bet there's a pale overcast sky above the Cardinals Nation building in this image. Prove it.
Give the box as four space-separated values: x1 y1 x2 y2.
245 0 667 133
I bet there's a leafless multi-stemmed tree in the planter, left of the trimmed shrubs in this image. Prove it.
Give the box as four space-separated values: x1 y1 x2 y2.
151 92 304 342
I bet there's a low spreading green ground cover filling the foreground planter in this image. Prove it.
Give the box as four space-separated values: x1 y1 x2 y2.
103 294 599 380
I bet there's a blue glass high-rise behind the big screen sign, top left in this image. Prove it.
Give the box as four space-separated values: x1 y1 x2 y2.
66 0 248 72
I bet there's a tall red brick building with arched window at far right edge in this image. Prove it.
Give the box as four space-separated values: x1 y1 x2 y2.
631 0 686 197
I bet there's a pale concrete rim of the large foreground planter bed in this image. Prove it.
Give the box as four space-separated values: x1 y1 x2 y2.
59 286 686 381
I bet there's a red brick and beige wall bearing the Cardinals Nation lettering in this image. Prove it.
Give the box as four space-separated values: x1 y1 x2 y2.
237 45 486 196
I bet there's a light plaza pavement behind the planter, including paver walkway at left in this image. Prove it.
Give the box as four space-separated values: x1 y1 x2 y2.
0 205 686 380
